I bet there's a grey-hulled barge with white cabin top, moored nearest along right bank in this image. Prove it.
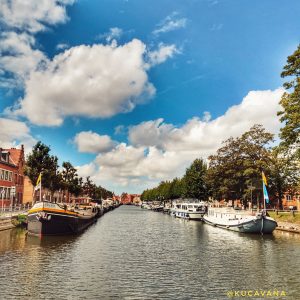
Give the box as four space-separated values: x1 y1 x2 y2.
203 207 277 233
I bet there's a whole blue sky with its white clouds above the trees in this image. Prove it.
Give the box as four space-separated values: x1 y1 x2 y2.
0 0 300 194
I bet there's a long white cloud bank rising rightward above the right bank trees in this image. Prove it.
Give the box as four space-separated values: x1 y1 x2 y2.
77 89 284 192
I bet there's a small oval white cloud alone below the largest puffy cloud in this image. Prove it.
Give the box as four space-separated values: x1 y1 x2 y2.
74 131 116 153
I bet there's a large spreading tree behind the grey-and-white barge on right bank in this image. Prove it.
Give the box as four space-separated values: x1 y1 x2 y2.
207 125 273 205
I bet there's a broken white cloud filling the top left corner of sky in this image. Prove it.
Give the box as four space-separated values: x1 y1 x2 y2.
0 0 74 88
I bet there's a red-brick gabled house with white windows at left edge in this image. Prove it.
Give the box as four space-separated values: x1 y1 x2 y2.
0 145 24 207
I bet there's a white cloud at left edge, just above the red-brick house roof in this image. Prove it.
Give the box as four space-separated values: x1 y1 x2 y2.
0 118 36 151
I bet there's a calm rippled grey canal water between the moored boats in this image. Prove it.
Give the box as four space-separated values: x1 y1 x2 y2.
0 206 300 299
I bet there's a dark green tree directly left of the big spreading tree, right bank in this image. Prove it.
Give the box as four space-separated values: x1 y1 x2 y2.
184 159 208 200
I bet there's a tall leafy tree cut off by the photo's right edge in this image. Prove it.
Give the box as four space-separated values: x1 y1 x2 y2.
278 45 300 158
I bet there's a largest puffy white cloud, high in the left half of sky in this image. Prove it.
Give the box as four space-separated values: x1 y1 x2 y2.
12 39 155 126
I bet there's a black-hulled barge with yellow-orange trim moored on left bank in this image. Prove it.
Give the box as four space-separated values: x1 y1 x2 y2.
27 201 100 236
